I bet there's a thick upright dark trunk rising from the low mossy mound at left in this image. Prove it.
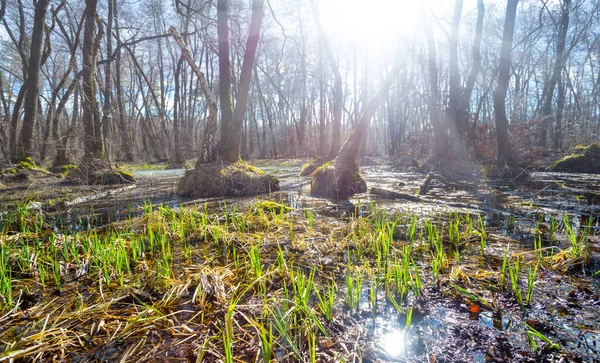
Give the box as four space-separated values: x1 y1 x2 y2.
82 0 104 160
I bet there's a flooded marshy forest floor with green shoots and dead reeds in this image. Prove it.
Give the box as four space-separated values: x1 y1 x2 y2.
0 160 600 362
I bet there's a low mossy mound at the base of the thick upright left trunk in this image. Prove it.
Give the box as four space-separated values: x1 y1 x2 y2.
66 160 135 185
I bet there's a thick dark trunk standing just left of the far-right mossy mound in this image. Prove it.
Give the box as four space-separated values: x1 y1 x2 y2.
494 0 519 166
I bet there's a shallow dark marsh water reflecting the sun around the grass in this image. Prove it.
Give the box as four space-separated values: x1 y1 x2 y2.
0 165 600 362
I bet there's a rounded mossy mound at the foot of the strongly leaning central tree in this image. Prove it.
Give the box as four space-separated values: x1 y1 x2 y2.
310 159 367 200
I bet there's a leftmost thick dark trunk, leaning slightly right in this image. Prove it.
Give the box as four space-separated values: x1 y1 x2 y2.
13 0 50 157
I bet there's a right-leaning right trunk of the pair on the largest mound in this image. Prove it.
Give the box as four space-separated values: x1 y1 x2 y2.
219 0 265 163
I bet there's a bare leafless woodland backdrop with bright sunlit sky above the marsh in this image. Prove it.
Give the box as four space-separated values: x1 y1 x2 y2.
0 0 600 166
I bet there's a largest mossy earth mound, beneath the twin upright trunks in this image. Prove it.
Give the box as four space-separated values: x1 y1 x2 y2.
177 161 279 198
